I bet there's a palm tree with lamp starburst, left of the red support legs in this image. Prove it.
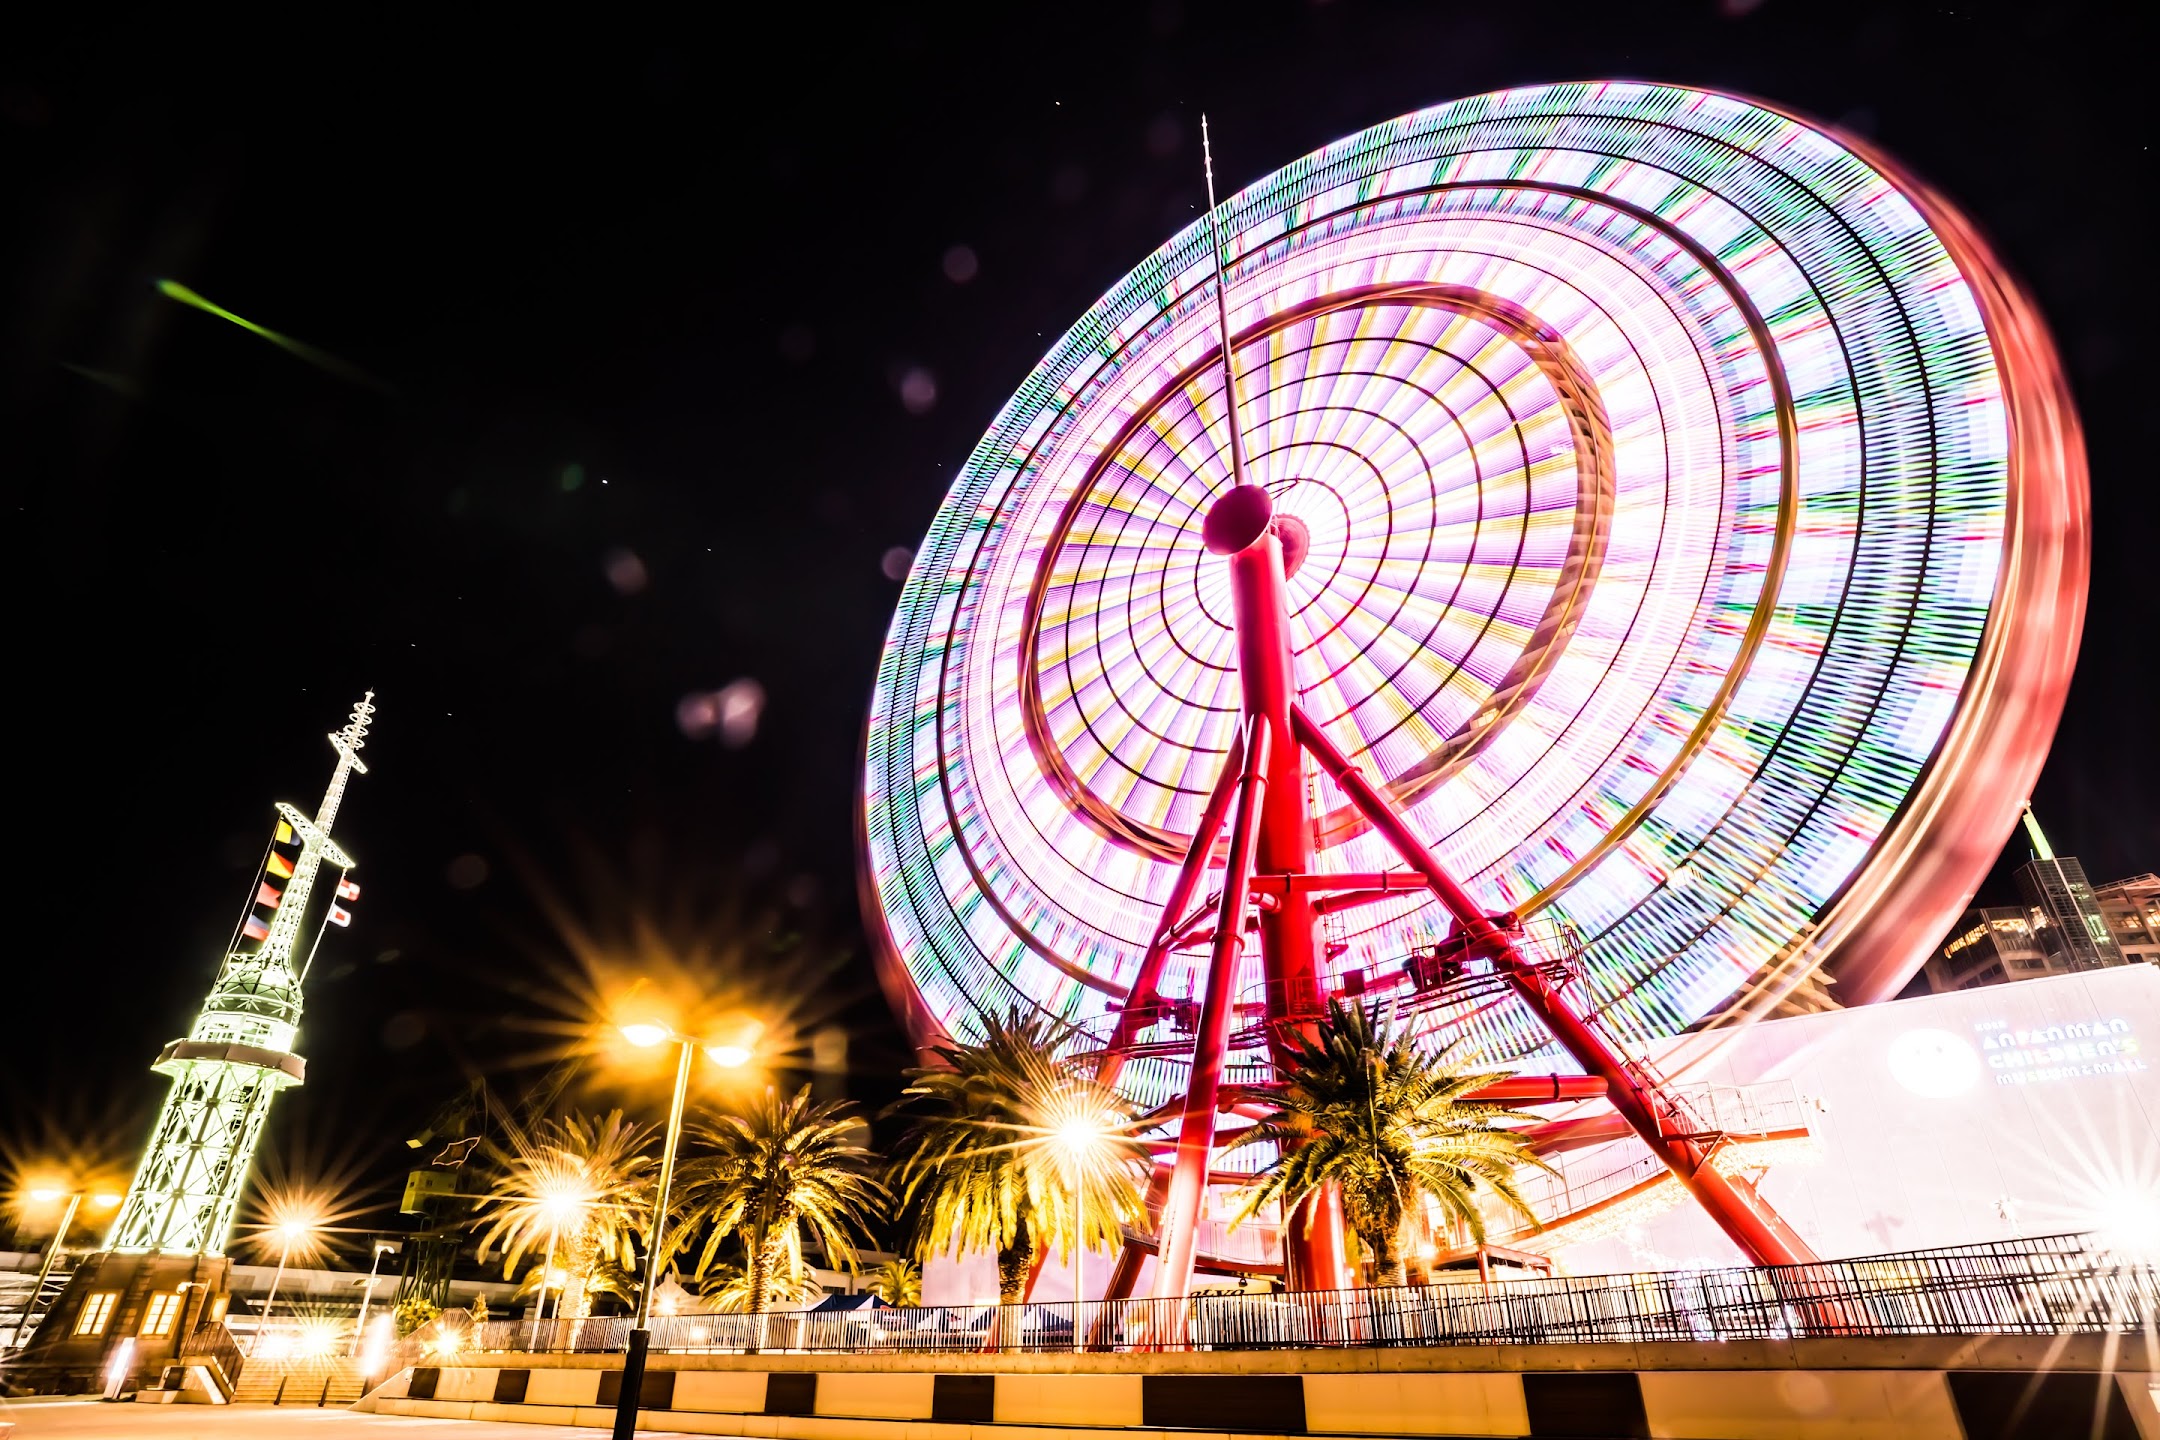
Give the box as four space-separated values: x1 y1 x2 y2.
892 1013 1145 1338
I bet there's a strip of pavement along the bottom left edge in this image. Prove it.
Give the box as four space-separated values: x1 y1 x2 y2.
0 1399 689 1440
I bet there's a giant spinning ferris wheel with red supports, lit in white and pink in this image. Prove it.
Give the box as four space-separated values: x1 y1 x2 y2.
862 84 2087 1285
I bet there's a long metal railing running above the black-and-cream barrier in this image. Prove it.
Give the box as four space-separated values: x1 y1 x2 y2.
395 1235 2160 1364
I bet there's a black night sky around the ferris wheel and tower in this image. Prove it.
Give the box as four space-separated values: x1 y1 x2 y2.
0 0 2160 1243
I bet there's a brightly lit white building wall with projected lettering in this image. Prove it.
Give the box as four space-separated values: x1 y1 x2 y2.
1557 965 2160 1274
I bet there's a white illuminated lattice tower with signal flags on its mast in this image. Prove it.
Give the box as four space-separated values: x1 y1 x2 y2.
110 691 376 1254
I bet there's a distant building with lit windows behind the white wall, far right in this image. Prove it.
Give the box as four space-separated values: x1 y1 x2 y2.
1922 805 2160 995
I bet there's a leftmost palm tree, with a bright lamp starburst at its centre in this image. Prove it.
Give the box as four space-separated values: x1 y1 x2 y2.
480 1110 652 1319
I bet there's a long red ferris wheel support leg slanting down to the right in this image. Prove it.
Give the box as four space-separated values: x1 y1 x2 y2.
1292 710 1817 1265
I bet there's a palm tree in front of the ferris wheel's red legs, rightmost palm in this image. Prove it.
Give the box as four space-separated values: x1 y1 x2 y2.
1238 1000 1547 1285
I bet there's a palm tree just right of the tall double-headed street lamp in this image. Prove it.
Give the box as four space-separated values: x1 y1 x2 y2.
676 1086 888 1338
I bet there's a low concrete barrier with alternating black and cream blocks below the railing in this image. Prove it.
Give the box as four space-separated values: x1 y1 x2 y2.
356 1336 2160 1440
